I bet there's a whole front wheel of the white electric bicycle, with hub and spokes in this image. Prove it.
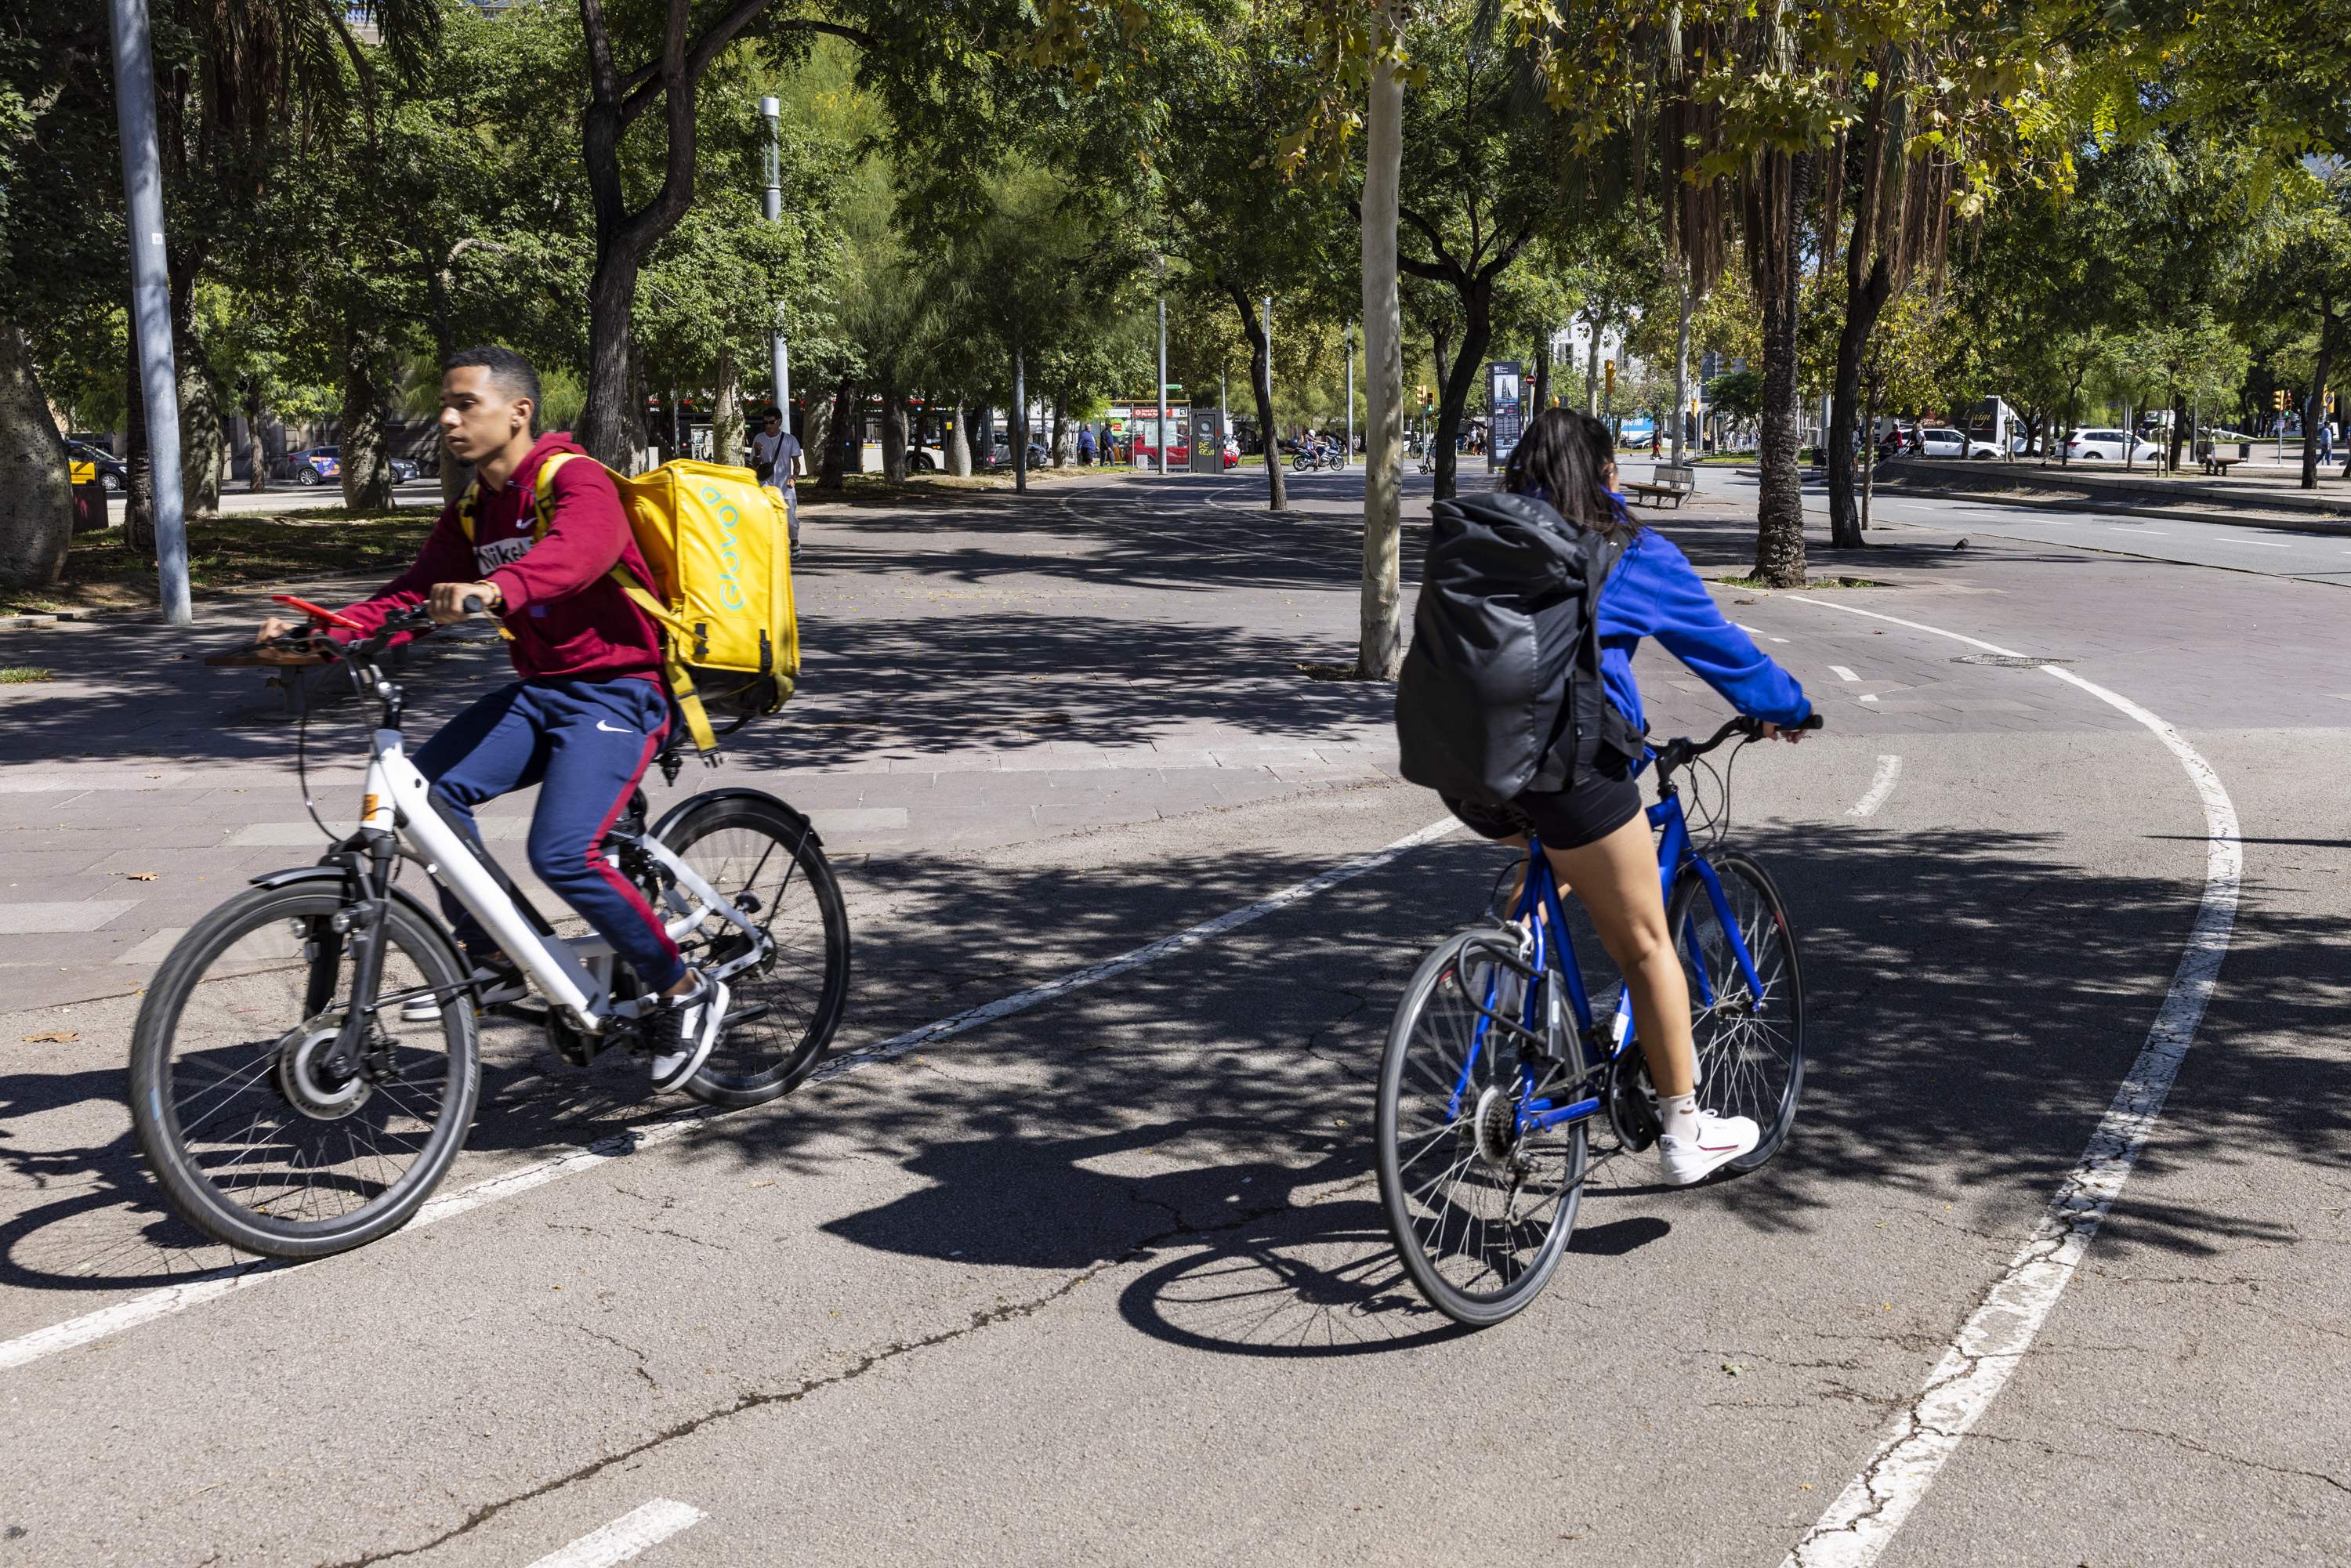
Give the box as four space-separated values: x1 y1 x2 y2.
132 884 482 1258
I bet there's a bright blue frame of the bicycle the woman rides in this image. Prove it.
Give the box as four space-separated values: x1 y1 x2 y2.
1448 780 1763 1138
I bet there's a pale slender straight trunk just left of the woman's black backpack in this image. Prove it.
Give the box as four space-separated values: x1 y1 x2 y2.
1354 40 1401 679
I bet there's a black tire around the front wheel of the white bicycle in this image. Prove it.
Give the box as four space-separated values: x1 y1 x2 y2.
129 886 482 1262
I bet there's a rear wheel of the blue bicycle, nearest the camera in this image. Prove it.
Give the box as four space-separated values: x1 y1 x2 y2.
1373 926 1587 1328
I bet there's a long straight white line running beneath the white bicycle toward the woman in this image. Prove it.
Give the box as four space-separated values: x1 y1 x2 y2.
0 816 1460 1371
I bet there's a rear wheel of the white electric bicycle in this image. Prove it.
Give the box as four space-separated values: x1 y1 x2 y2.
661 792 849 1107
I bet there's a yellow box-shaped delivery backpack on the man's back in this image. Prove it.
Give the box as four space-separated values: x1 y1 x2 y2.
456 451 799 757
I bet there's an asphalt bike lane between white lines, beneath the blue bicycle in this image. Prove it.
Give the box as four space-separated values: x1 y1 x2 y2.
9 484 2323 1561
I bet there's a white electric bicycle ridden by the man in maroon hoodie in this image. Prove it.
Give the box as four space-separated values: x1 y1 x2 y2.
129 602 849 1258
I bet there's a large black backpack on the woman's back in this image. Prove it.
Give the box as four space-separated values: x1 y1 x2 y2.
1396 491 1641 806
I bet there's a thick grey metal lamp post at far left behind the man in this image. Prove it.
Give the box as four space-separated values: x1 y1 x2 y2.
106 0 190 625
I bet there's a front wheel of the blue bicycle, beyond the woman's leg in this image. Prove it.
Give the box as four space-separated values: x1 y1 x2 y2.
1667 851 1803 1171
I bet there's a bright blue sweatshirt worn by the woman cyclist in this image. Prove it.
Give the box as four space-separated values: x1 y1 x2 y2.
1601 498 1813 748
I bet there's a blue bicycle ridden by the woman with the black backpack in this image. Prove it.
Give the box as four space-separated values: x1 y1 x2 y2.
1375 715 1820 1328
